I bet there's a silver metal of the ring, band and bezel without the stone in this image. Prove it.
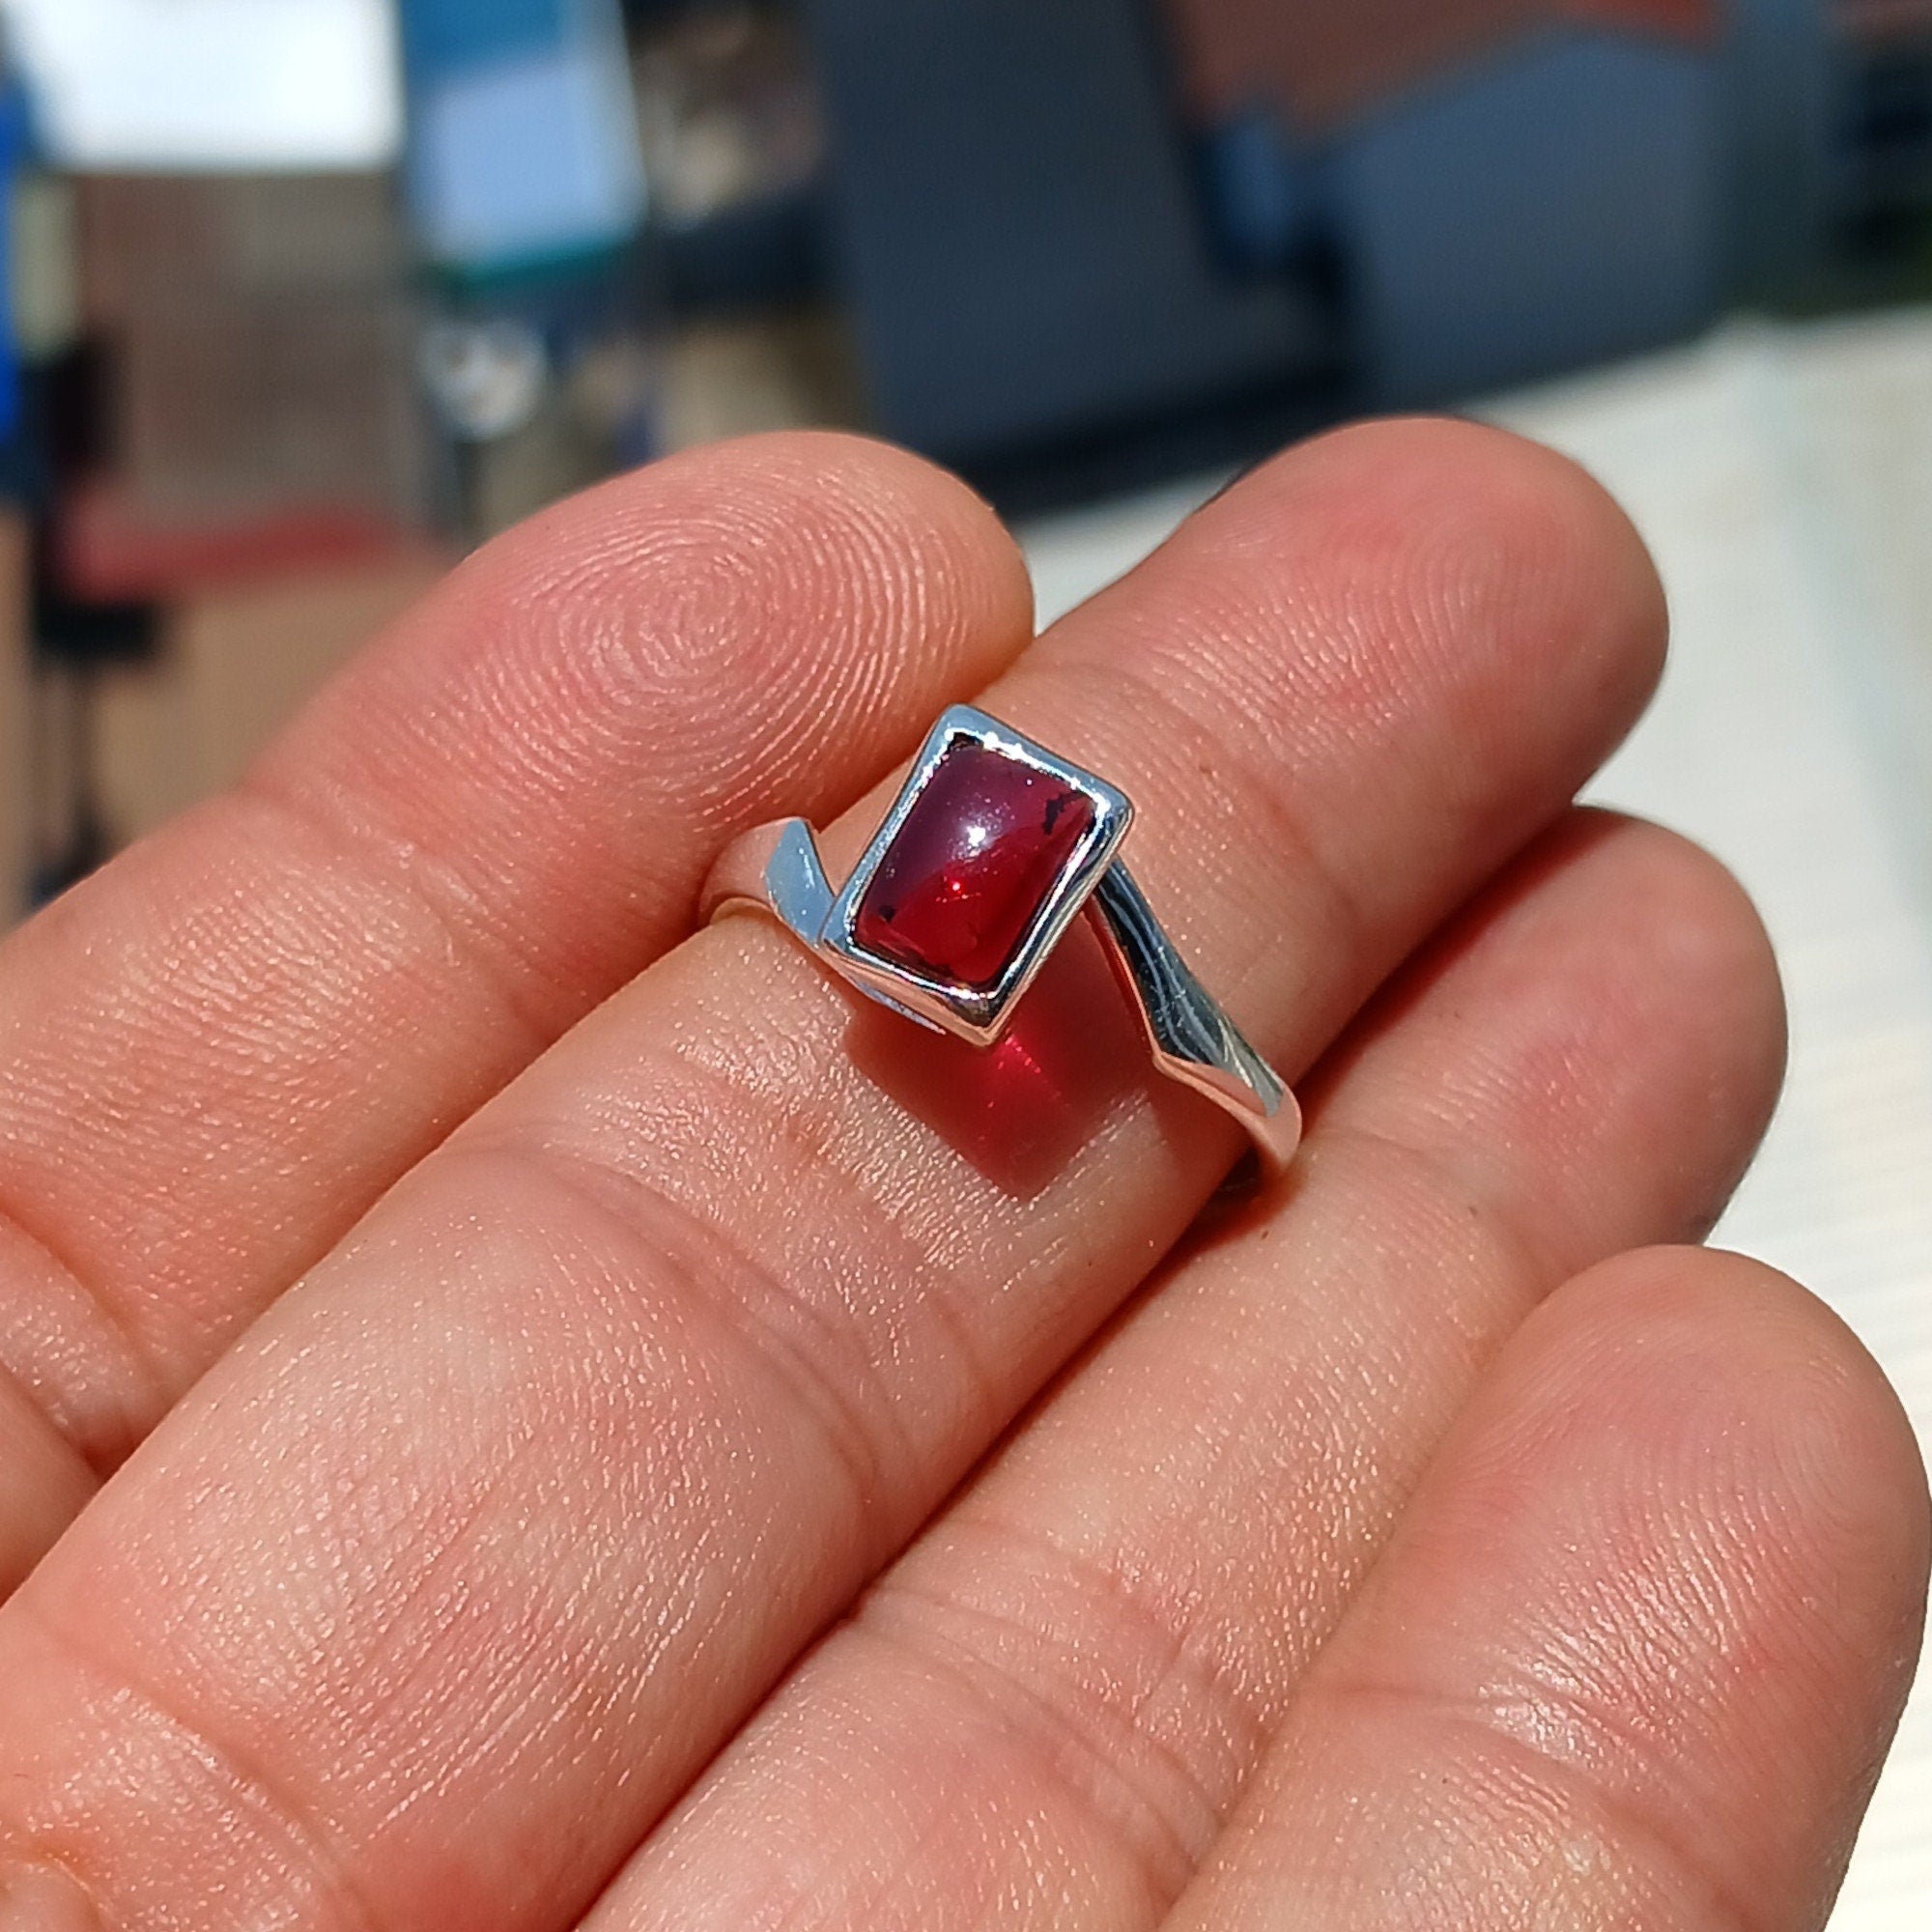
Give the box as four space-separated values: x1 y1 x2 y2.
701 705 1302 1169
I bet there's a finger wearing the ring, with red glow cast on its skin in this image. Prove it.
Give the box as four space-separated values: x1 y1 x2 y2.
0 425 1662 1932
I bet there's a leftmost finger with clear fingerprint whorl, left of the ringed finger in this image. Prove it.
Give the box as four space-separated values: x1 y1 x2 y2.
0 435 1032 1553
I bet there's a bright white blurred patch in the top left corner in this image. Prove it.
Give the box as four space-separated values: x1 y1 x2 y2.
0 0 402 170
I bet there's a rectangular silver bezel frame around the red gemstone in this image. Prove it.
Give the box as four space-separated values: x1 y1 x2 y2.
819 705 1134 1047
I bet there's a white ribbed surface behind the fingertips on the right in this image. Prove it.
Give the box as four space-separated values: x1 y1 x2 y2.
1028 313 1932 1932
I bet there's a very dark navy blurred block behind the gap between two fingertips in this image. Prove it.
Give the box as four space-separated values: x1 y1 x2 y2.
806 0 1339 500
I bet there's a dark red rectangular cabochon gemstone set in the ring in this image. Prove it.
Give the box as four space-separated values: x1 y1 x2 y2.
854 742 1094 993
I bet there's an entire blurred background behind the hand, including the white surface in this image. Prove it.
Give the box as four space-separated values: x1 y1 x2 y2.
0 0 1932 1932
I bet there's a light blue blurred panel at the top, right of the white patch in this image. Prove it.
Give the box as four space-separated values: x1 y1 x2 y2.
400 0 645 278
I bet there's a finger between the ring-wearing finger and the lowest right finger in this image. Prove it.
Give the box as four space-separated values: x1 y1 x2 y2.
589 813 1783 1932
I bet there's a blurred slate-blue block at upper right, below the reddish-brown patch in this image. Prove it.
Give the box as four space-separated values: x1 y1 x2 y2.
1323 27 1729 406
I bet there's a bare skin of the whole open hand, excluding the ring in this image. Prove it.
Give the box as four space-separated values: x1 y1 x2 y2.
0 423 1926 1932
